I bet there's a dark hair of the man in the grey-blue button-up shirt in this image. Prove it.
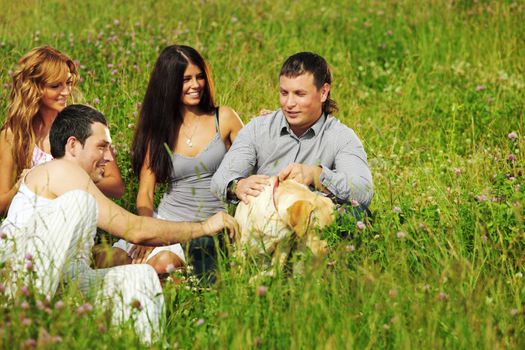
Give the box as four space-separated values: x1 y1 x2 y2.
279 52 338 114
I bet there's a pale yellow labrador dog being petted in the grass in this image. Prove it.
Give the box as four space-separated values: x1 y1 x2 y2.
235 176 334 266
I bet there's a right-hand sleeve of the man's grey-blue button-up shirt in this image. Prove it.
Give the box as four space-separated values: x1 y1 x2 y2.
320 131 373 207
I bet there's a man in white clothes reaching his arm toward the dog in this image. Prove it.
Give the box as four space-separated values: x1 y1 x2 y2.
0 105 238 342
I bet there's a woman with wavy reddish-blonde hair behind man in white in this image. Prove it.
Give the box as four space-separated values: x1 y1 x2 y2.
0 46 124 214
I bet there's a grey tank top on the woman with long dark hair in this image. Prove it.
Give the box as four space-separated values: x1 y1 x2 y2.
158 108 227 221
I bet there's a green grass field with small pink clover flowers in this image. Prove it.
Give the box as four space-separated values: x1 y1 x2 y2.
0 0 525 349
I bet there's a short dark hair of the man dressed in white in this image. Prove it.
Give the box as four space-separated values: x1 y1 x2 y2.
49 105 108 158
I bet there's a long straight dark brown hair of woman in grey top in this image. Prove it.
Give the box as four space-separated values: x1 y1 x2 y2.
132 45 215 183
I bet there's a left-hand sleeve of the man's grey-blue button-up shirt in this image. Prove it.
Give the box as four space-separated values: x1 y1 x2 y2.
210 122 257 201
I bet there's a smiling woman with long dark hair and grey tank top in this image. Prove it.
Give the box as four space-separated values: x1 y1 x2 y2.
114 45 243 275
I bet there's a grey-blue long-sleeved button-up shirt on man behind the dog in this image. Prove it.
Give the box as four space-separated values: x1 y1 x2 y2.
211 110 373 206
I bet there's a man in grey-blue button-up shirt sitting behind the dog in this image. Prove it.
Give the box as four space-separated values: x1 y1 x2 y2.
211 52 373 210
